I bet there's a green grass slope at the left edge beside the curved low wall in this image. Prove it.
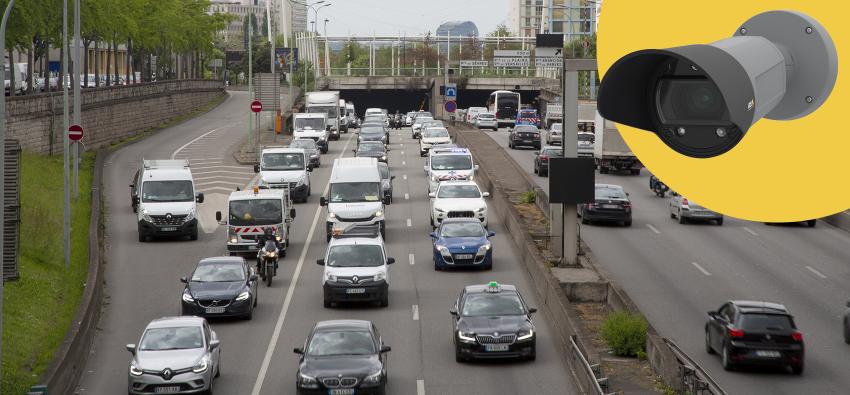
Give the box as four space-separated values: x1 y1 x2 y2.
2 152 94 394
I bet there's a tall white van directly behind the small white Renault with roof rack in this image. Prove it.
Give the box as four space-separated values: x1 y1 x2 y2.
320 158 388 241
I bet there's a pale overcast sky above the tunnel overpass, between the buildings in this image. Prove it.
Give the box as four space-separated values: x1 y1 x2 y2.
308 0 509 37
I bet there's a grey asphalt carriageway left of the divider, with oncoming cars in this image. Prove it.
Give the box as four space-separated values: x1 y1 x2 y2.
78 92 575 395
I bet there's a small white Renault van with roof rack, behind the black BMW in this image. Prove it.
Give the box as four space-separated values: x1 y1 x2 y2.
316 224 395 308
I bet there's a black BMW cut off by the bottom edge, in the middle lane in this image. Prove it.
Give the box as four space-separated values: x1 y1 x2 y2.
293 320 390 395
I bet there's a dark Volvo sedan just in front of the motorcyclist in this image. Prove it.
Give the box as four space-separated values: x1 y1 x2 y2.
180 256 258 320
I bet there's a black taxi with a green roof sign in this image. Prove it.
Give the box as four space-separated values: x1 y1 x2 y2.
450 282 537 362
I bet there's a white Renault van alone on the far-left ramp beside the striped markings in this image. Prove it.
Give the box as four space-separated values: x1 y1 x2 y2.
130 159 204 242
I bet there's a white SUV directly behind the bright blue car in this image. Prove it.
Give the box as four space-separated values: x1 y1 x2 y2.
428 181 490 227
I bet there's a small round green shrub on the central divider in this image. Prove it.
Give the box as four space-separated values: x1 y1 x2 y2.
602 311 649 357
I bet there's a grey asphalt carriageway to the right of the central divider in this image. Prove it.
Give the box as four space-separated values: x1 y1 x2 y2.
482 129 850 394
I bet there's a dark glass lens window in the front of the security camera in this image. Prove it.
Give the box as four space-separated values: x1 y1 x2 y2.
657 79 726 123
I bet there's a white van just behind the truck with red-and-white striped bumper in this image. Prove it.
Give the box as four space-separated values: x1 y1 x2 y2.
254 147 313 203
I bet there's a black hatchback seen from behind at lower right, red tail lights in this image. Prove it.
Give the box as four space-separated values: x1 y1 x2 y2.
705 300 804 375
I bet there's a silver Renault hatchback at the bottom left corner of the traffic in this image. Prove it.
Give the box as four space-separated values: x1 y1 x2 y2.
127 316 221 395
